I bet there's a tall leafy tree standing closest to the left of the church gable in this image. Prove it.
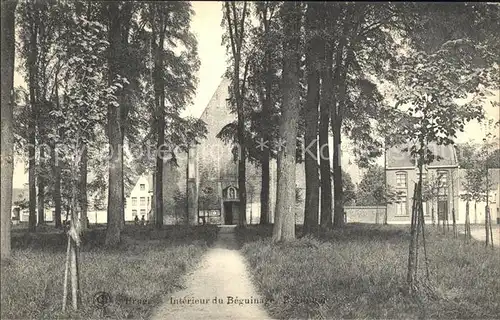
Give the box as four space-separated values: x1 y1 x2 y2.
138 1 200 228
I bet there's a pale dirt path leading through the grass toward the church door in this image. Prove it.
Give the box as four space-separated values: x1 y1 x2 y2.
152 227 271 320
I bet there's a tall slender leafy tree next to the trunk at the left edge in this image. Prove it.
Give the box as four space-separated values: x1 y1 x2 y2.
19 1 72 230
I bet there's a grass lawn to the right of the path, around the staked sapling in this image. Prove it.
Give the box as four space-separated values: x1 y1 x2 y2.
237 224 500 319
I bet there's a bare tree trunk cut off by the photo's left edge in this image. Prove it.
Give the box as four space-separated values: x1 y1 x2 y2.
0 1 17 260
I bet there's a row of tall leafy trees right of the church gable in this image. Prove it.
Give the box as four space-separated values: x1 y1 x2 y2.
220 1 500 241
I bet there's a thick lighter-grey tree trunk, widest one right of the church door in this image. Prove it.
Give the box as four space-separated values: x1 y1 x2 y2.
273 2 301 242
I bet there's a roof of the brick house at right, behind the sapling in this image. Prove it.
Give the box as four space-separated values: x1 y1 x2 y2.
387 143 458 168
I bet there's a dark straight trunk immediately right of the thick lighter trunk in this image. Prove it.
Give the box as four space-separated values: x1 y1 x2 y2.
304 3 324 234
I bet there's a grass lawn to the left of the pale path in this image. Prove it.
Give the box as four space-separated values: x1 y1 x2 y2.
1 226 217 319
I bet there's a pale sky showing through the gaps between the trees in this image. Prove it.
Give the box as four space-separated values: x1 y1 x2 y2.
9 1 500 188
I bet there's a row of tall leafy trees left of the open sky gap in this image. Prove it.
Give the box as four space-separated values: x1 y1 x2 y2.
2 0 205 257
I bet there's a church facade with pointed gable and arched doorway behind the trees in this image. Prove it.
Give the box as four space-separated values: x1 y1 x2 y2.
163 79 305 225
